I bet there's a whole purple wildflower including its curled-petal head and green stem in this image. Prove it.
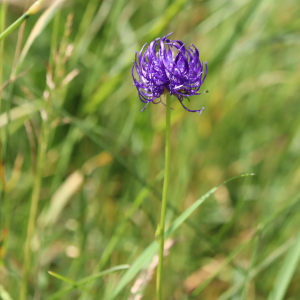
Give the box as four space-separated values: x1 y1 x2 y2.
132 33 208 300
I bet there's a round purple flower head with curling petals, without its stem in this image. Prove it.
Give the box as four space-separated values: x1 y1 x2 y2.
132 33 208 114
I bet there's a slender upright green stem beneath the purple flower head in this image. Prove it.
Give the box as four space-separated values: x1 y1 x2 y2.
156 93 171 300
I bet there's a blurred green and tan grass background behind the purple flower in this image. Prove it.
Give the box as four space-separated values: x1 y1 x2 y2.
0 0 300 300
